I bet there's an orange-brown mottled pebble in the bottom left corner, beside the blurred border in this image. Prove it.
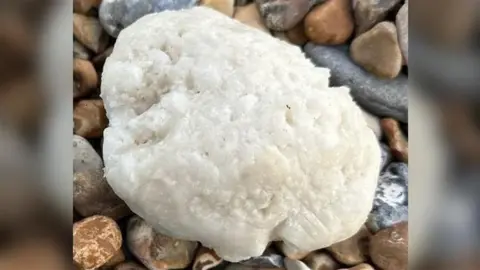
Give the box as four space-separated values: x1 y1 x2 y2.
73 216 122 269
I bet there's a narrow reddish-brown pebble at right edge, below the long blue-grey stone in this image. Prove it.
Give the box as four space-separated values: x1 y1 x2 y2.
380 118 408 163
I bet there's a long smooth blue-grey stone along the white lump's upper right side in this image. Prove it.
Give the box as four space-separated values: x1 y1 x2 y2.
304 43 408 123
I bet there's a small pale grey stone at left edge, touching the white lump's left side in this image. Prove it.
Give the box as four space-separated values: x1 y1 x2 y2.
73 135 103 173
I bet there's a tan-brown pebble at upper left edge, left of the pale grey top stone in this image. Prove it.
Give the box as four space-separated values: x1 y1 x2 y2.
73 13 109 54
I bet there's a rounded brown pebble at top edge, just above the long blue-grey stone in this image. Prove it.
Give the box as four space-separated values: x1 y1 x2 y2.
305 0 354 45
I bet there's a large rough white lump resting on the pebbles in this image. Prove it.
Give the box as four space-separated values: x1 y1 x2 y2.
101 7 380 261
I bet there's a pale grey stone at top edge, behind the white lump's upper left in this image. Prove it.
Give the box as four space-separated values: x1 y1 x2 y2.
98 0 198 38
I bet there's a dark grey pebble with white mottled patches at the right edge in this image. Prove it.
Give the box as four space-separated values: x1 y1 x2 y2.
366 162 408 233
